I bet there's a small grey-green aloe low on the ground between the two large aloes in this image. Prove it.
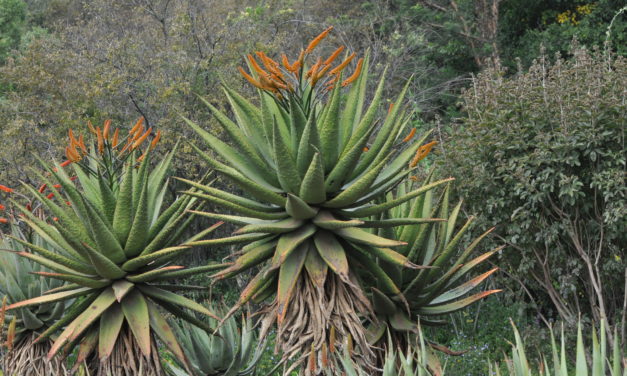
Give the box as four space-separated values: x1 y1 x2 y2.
169 308 265 376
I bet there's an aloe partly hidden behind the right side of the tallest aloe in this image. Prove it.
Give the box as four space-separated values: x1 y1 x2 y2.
365 175 502 351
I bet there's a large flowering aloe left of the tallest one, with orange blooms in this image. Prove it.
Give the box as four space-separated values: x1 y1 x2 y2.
2 124 222 376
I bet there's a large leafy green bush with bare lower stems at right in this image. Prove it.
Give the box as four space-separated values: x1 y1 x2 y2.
441 44 627 324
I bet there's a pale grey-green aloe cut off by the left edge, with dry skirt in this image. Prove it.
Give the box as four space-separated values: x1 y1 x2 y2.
0 222 66 376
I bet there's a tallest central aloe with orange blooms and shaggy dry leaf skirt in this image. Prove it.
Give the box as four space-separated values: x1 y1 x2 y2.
185 30 450 374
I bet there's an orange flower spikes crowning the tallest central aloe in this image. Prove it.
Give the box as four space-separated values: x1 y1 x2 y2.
239 26 364 98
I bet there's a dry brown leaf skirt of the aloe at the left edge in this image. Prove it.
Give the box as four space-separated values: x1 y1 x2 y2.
2 332 69 376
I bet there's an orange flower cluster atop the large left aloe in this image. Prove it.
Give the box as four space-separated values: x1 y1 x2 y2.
64 117 161 163
